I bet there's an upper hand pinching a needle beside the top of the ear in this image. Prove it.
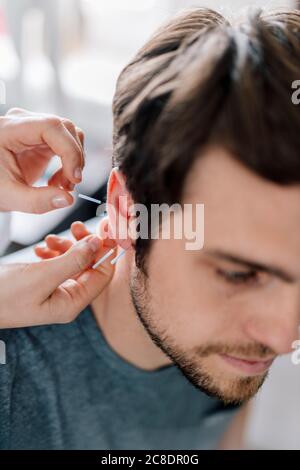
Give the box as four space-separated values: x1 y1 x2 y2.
0 108 88 214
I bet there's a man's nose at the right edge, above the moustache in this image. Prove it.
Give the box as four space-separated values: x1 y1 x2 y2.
245 286 300 355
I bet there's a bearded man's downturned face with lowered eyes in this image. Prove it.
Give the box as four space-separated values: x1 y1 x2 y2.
130 148 300 402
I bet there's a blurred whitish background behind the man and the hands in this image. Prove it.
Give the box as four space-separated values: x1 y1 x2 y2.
0 0 300 449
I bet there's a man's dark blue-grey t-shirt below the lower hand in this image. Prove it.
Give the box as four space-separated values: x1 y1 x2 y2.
0 308 238 450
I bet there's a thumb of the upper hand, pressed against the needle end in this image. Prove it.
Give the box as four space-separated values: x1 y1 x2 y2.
10 182 73 214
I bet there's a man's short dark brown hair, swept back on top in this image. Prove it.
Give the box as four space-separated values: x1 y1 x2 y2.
113 8 300 267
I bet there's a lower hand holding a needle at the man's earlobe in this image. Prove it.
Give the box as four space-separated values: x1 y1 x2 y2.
0 232 115 328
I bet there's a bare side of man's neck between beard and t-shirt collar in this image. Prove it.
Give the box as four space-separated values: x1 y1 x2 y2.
91 250 171 370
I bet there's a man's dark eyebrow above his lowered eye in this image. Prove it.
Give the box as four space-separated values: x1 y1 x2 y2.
205 250 297 283
